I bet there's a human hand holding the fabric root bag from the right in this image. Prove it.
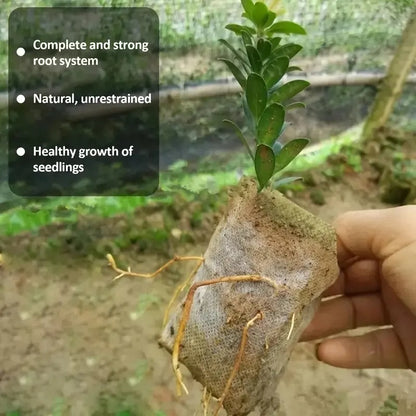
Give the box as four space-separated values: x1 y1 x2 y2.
301 205 416 371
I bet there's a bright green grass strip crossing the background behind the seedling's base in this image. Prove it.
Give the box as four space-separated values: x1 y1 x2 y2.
0 127 360 236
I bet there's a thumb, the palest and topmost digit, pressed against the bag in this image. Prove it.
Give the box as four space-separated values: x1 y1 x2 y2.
334 205 416 268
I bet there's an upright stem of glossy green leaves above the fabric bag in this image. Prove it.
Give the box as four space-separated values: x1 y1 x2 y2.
220 0 309 191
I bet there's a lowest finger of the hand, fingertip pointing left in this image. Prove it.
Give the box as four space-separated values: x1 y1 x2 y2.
317 328 409 368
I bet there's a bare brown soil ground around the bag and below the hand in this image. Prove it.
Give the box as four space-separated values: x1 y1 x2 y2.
0 174 416 416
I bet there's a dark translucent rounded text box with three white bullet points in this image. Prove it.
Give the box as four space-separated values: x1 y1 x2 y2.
9 8 159 196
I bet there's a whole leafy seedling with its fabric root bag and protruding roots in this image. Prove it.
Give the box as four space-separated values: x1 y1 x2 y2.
107 0 338 416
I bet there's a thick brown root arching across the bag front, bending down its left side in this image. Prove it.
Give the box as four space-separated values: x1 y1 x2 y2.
172 275 285 396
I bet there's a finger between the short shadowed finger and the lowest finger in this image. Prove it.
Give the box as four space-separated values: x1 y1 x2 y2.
301 294 390 341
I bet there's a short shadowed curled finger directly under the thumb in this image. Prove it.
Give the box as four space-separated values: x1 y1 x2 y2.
324 260 380 297
